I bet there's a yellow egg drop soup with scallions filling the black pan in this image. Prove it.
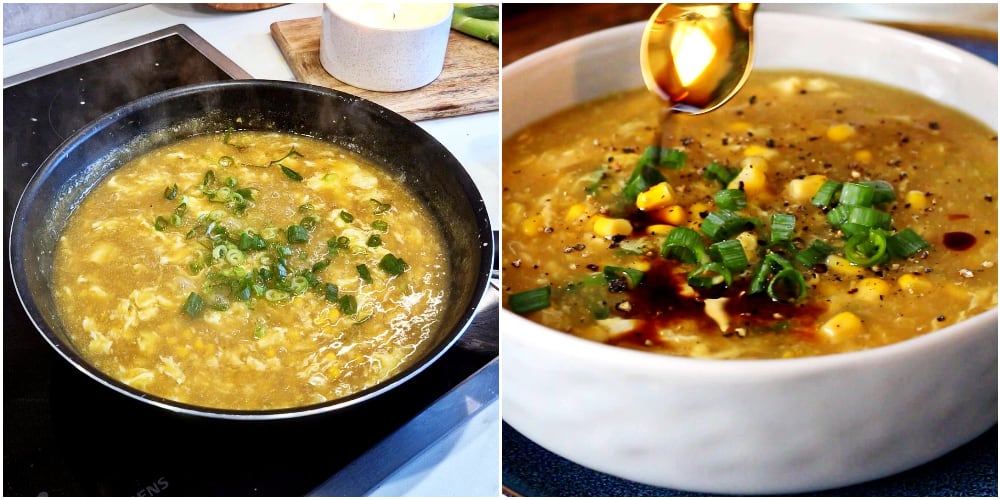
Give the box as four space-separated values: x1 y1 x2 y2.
54 131 449 410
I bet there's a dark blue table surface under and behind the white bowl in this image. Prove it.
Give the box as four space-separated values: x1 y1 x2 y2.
501 28 998 497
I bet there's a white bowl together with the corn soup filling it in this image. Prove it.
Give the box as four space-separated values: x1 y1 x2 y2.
501 13 997 494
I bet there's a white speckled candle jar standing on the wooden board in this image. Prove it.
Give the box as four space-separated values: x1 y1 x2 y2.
320 2 454 92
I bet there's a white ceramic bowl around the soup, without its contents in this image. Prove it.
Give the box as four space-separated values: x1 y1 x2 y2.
501 13 997 494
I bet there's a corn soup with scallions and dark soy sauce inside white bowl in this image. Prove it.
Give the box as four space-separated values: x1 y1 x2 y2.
502 71 997 358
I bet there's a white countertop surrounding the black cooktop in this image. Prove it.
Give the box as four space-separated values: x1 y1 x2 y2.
3 3 500 497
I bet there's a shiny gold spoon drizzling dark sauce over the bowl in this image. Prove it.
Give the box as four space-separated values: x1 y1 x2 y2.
639 3 757 114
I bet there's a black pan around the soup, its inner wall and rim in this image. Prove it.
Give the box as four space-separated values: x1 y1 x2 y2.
10 80 494 420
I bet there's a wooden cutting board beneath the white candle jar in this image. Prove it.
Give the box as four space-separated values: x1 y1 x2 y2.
271 17 500 121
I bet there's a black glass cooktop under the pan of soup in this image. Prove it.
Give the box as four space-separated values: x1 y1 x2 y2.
3 26 498 496
